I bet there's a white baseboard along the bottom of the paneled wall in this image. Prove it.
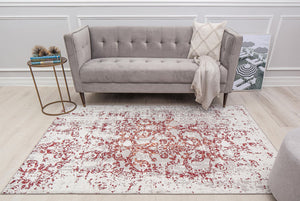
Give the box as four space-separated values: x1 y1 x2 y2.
0 76 300 87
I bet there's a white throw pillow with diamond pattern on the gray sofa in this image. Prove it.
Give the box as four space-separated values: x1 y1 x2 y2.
188 21 227 61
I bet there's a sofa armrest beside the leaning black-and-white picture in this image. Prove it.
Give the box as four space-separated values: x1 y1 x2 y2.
220 28 243 93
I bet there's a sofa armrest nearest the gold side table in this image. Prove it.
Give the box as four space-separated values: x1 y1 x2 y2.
64 26 91 92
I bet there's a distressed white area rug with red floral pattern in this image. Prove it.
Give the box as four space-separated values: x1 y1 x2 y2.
3 105 277 194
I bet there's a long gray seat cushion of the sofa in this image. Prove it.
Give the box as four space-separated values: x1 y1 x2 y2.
79 57 227 84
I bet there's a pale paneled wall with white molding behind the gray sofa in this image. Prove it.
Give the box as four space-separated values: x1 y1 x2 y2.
0 0 300 86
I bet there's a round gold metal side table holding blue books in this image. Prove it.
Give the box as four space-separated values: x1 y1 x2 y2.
27 57 77 116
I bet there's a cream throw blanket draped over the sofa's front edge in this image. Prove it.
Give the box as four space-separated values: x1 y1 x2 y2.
191 55 220 110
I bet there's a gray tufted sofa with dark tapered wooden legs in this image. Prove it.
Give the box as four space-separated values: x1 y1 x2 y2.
64 26 242 107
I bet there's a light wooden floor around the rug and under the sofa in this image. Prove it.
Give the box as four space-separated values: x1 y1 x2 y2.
0 87 300 201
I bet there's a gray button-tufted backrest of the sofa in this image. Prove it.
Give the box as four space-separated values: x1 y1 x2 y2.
89 27 193 59
